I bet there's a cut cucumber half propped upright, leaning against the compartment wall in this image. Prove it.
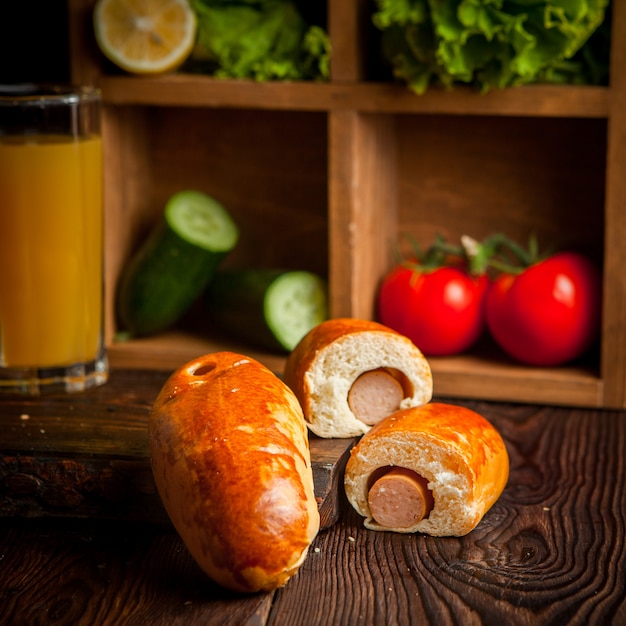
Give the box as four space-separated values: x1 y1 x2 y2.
117 191 239 336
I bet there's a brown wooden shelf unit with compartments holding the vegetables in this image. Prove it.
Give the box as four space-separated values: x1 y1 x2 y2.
68 0 626 407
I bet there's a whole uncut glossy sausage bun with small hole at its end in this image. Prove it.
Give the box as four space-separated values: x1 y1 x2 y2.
148 352 320 592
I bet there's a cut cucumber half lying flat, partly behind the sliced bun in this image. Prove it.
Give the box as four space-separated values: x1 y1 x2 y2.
206 269 328 352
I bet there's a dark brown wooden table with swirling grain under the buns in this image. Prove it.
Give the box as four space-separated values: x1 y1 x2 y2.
0 374 626 626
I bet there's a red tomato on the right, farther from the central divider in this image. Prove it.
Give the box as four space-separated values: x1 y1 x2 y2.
485 252 601 366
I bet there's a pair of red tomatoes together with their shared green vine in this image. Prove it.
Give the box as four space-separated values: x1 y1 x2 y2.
377 233 602 367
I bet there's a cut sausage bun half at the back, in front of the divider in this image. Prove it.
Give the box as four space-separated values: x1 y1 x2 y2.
283 318 433 438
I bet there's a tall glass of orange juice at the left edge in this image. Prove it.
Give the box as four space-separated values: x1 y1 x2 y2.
0 84 108 395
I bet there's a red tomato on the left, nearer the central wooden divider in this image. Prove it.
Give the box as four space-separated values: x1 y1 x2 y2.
378 265 488 356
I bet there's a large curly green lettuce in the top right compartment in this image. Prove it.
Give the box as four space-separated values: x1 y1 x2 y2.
372 0 609 94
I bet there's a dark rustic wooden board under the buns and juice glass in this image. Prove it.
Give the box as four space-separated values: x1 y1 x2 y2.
0 370 355 528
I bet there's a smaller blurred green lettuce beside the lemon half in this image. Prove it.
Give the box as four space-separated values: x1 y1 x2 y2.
191 0 330 81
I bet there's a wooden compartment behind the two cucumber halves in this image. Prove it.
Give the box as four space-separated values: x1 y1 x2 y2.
98 106 328 367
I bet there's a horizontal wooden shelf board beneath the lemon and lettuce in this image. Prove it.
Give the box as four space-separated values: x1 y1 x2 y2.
100 74 609 118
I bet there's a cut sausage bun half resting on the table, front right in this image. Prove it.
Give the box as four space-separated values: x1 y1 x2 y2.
344 403 509 537
